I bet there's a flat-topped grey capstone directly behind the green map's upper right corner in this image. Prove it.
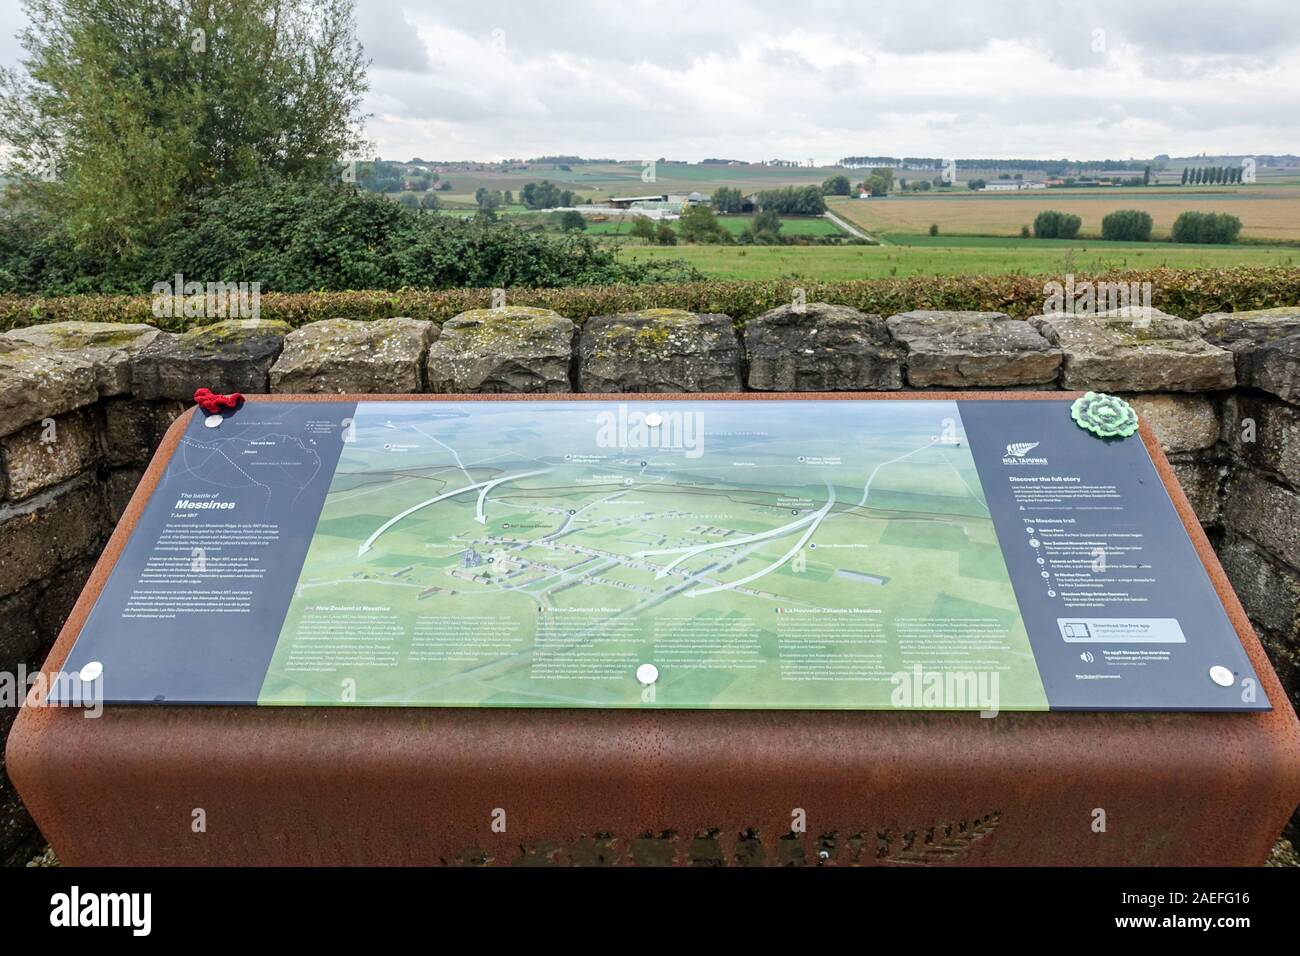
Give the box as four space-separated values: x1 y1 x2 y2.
887 311 1061 388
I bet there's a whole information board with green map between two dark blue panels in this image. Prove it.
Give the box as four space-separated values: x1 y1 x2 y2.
55 398 1269 713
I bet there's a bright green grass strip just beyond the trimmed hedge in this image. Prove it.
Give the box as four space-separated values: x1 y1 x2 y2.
620 235 1300 281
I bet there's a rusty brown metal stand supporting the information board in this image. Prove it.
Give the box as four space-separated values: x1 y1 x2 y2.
7 393 1300 865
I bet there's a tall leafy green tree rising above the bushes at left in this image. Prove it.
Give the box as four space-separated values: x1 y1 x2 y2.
0 0 367 259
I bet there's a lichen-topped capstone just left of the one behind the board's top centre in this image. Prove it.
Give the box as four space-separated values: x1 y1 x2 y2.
425 306 576 393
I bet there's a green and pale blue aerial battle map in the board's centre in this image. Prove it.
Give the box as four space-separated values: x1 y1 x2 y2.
259 401 1047 710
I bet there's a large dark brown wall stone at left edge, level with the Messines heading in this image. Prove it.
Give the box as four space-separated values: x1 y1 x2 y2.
0 475 108 594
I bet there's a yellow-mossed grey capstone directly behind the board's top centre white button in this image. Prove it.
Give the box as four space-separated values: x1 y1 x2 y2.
577 308 741 392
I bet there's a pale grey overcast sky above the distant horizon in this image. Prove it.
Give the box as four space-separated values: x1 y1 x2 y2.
0 0 1300 163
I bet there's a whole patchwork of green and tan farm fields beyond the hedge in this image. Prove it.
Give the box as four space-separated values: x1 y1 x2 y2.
403 163 1300 280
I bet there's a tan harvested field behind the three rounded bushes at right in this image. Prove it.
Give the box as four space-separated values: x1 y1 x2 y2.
829 186 1300 242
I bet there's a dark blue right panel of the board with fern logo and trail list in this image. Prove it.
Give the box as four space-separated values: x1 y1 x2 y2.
958 399 1269 710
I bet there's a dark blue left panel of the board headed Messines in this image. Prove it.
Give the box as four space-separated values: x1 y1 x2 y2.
55 402 356 704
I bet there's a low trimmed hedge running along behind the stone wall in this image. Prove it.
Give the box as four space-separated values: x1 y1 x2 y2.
0 267 1300 330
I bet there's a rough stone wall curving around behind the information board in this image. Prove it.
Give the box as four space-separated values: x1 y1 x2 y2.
0 303 1300 862
